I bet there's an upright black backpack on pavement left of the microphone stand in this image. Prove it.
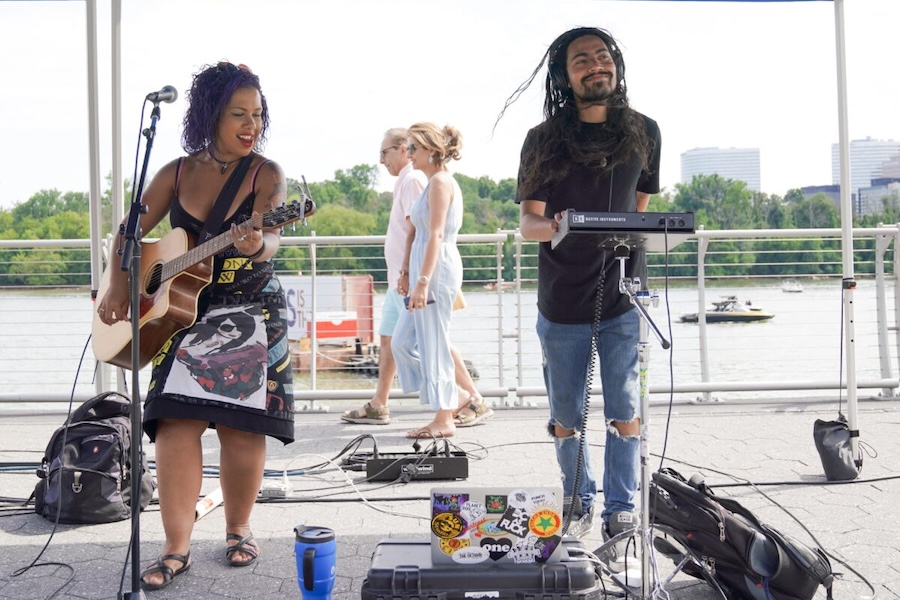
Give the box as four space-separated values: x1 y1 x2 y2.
34 392 155 523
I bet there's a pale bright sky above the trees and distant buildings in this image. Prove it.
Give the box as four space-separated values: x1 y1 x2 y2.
0 0 900 208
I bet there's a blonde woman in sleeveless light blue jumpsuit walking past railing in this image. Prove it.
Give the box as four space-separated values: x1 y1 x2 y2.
391 123 463 438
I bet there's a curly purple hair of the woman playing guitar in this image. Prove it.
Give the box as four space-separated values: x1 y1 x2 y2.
181 62 269 154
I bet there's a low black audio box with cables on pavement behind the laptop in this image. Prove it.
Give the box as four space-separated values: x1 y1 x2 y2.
344 447 469 481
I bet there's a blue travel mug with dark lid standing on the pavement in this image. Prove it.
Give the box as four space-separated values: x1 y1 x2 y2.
294 525 337 600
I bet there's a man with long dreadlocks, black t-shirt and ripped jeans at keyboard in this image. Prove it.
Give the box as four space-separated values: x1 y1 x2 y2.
501 27 660 570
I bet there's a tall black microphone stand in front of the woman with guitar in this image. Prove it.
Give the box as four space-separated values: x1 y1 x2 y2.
119 101 159 600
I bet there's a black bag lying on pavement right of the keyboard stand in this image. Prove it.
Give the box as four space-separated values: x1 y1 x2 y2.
650 469 834 600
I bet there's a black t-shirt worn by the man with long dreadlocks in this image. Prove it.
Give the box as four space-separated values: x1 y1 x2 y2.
516 115 661 324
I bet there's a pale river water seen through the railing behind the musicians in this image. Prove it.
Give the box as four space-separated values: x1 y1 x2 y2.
0 281 897 406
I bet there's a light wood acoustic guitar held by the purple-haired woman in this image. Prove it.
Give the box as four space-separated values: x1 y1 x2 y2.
91 197 315 369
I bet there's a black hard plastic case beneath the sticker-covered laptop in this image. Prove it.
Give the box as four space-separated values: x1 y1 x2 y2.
362 538 603 600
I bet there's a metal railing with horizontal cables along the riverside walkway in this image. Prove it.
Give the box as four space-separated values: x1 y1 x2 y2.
0 225 900 410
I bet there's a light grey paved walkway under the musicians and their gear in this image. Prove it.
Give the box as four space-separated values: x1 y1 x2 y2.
0 398 900 600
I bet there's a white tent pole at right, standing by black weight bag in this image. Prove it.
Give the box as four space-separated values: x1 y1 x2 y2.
834 0 859 459
